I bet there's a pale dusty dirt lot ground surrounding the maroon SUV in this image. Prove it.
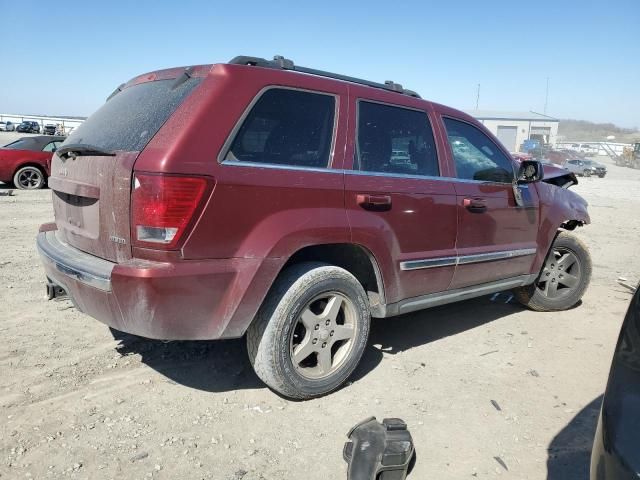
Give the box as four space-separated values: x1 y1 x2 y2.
0 134 640 480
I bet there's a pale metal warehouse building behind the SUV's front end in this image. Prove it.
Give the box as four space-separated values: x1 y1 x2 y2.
466 110 560 152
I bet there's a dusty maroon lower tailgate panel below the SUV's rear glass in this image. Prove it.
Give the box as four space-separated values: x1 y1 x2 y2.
49 152 138 262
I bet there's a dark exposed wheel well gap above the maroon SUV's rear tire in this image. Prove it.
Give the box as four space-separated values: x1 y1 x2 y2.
283 243 385 316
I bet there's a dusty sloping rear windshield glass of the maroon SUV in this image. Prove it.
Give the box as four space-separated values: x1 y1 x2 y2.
65 78 202 152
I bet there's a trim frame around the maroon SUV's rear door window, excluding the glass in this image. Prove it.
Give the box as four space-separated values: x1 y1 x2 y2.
352 97 446 180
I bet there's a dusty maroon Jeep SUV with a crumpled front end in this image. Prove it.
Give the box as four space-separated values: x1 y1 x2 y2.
37 57 591 398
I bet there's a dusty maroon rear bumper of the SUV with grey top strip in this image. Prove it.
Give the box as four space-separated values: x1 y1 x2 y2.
37 230 279 340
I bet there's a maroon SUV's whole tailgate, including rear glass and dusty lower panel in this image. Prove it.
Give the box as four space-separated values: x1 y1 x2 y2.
49 71 208 262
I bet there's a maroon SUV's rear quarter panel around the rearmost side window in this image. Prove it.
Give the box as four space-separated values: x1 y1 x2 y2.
134 65 349 259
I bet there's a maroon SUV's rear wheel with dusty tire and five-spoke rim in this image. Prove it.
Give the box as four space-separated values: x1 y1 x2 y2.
247 262 371 399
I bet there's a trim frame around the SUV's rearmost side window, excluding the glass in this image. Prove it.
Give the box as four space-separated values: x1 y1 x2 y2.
217 85 340 172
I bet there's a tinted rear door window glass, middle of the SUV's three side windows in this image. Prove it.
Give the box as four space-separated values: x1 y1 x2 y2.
354 101 440 176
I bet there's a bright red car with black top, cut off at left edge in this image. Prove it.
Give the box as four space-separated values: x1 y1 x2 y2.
0 136 65 190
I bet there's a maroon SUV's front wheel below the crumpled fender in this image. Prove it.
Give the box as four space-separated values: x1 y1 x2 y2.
513 232 592 312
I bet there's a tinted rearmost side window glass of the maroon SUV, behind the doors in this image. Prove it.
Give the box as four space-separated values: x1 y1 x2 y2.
224 88 336 168
